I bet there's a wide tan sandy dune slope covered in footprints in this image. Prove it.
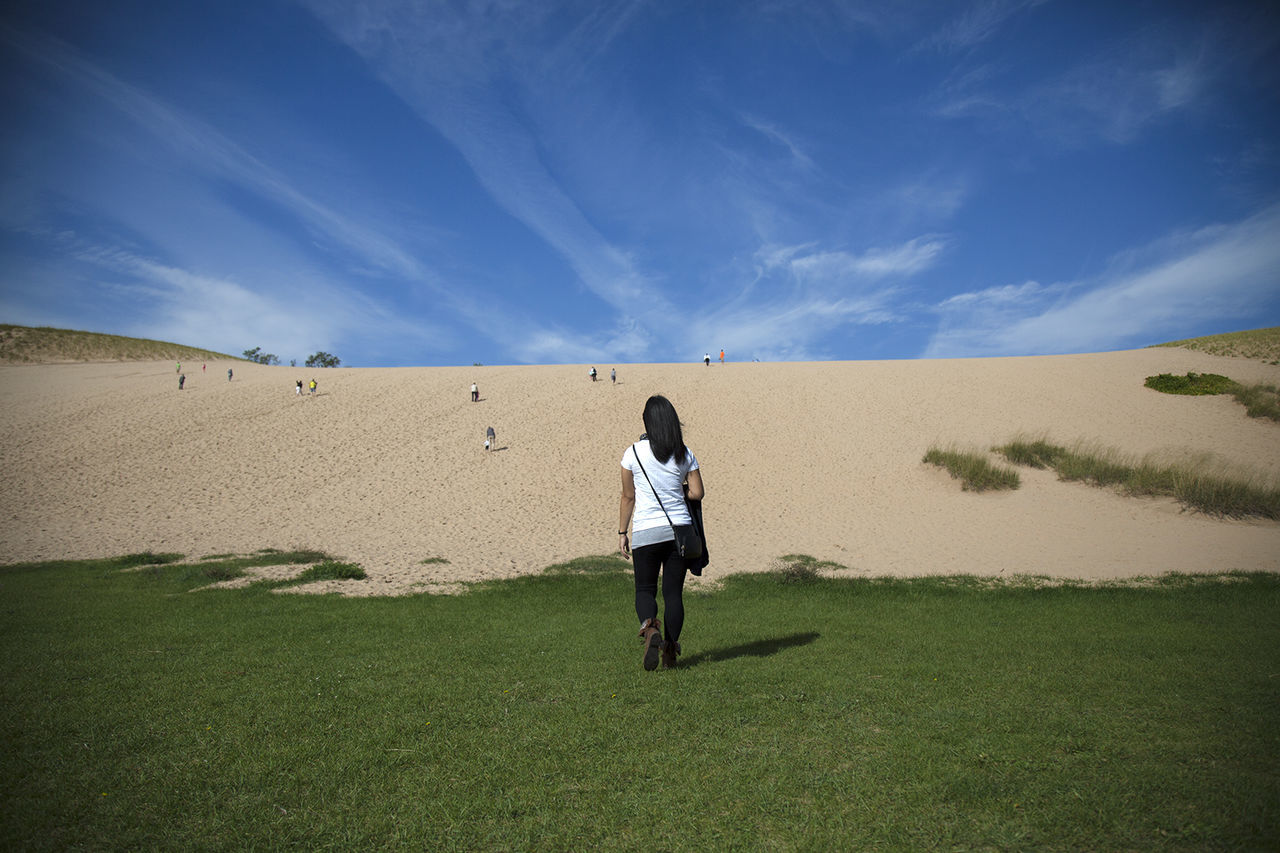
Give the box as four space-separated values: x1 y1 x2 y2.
0 348 1280 593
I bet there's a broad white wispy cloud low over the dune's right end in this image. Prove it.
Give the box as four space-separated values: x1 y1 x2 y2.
923 205 1280 357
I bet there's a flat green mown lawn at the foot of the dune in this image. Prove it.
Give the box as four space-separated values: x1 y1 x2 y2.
0 550 1280 850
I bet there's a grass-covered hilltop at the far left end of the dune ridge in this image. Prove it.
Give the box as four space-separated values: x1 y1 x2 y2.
0 324 243 364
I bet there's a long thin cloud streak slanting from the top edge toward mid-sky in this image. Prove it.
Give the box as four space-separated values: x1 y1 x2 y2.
298 0 671 318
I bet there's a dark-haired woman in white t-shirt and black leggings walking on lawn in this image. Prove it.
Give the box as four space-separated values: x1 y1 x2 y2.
618 394 703 670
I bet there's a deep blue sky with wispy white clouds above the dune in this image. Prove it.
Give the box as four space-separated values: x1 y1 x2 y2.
0 0 1280 366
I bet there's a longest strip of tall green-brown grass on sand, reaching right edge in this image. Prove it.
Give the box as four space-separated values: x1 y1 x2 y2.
996 437 1280 519
